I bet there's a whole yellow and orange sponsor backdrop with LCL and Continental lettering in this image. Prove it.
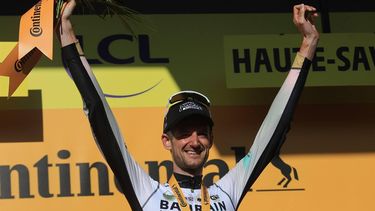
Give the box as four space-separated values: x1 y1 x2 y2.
0 14 375 211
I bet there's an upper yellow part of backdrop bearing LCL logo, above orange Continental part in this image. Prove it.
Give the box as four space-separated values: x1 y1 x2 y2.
0 14 375 108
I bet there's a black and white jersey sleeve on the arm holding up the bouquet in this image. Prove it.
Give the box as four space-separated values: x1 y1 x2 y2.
62 44 158 210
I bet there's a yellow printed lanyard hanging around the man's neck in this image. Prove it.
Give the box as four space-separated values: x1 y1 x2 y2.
168 174 210 211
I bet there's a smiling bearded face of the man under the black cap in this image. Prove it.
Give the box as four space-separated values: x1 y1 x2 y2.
164 116 212 174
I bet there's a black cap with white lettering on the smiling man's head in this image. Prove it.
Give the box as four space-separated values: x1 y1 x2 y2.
163 93 213 133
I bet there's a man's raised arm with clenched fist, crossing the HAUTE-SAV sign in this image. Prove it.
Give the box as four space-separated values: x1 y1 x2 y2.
216 4 319 209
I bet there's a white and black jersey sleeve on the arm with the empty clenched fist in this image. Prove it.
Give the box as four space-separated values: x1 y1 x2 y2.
214 54 311 209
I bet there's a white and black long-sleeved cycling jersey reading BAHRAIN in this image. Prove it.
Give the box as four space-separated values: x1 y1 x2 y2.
62 44 311 211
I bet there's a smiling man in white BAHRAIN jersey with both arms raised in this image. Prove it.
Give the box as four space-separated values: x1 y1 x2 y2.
59 0 319 211
